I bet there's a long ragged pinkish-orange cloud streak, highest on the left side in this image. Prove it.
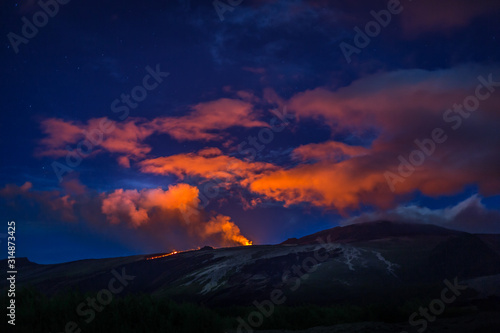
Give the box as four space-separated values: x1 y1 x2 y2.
35 95 268 167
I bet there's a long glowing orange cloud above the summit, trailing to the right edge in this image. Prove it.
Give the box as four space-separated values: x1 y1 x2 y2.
249 131 500 213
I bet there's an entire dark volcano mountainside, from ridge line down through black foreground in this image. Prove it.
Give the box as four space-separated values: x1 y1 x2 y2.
1 222 500 332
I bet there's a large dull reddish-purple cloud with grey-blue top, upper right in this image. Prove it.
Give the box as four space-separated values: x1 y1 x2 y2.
288 66 476 134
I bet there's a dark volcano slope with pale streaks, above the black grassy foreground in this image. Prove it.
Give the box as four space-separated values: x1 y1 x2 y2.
2 222 500 305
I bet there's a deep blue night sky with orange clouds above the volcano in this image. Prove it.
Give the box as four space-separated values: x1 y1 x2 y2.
0 0 500 263
